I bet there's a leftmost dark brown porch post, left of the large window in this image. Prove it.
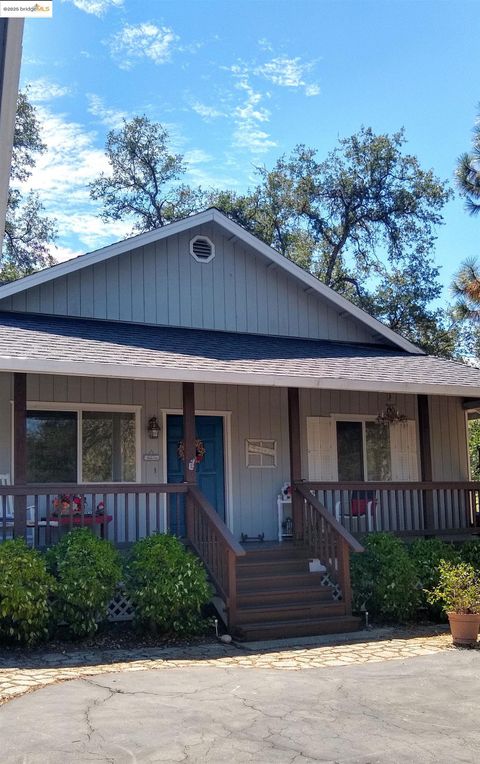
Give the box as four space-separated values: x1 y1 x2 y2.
13 373 27 538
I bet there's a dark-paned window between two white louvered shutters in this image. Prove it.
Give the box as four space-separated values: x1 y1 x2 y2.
337 421 392 482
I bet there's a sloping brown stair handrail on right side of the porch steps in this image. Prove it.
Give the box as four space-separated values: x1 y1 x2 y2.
294 483 363 615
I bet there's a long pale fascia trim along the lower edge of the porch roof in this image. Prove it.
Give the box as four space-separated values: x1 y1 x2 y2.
0 358 480 397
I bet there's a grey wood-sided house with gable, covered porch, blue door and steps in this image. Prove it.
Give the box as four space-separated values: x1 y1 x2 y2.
0 209 480 637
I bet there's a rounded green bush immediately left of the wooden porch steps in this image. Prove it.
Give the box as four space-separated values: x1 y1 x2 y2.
126 534 212 634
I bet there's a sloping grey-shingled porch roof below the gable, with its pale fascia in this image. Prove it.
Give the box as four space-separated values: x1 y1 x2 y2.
0 312 480 398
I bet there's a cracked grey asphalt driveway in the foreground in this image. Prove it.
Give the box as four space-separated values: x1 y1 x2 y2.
0 650 480 764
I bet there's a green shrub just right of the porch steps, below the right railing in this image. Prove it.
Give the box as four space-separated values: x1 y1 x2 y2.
351 533 420 621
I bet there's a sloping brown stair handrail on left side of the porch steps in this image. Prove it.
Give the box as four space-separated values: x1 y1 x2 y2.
187 485 245 631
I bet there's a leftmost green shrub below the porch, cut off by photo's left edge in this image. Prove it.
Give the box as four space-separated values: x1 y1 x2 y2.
0 539 54 645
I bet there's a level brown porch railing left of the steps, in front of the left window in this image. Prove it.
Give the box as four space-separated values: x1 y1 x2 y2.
0 483 188 547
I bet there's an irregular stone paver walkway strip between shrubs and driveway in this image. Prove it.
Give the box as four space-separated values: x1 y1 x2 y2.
0 630 458 704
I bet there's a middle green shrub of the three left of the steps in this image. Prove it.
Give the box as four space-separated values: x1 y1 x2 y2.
47 528 122 637
